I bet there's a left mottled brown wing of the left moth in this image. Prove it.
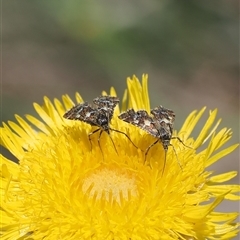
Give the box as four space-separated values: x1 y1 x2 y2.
63 102 99 126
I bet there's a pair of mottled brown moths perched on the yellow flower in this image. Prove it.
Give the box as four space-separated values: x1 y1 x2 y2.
63 96 182 171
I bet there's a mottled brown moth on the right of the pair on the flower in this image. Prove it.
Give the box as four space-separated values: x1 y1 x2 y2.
118 106 185 172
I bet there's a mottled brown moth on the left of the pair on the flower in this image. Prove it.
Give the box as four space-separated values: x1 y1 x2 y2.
63 96 137 154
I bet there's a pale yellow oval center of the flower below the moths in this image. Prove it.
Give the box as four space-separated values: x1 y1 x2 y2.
82 166 138 203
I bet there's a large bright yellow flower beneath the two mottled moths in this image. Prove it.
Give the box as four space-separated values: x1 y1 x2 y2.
0 75 240 240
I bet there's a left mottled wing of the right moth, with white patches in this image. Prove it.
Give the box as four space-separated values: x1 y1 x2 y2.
118 109 159 137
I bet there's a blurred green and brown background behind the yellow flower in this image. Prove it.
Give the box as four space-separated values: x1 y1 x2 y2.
1 0 239 229
